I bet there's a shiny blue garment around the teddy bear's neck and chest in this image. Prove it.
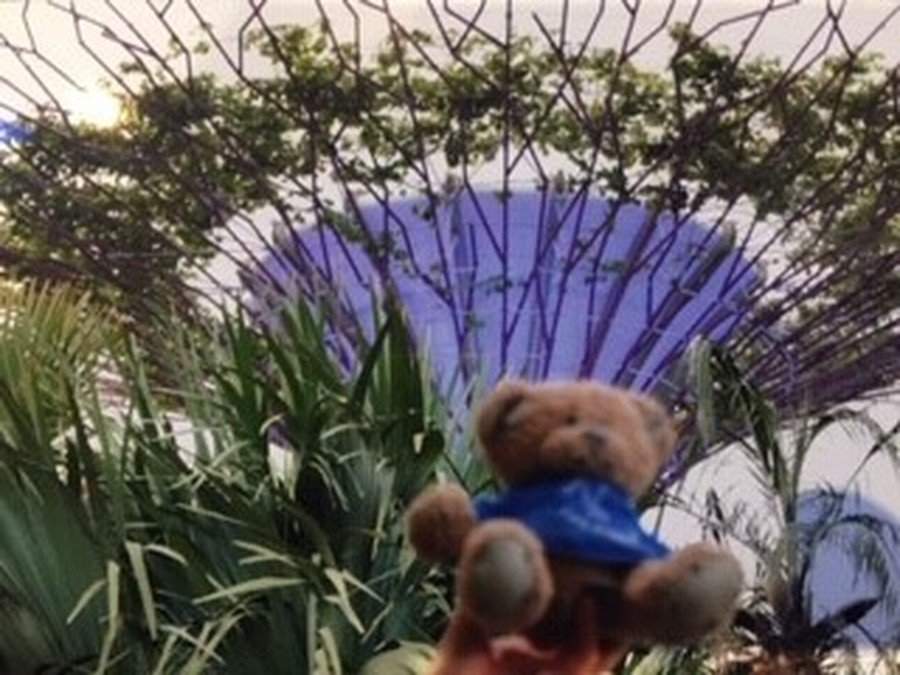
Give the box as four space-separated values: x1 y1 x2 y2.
475 478 670 564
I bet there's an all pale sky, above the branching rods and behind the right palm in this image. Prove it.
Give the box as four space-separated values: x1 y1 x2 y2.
0 0 900 644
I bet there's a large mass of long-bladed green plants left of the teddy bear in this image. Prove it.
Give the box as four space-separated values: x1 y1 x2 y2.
0 298 448 673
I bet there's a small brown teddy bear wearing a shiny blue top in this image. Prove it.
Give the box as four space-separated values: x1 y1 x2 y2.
406 380 742 675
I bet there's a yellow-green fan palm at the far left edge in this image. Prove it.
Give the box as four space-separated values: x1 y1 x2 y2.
0 283 121 673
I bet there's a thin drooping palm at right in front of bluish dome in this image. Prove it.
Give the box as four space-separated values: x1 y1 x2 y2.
684 351 900 673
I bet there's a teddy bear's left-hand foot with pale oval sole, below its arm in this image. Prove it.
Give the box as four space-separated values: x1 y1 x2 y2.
459 519 553 635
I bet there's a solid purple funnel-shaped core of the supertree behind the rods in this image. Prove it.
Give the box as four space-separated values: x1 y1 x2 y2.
248 188 760 402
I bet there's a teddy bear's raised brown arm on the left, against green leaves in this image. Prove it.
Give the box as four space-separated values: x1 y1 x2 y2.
406 485 477 564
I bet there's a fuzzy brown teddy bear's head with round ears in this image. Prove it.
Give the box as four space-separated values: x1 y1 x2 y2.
477 380 677 497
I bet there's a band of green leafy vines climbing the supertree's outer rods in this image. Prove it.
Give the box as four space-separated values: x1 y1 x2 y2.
0 3 900 406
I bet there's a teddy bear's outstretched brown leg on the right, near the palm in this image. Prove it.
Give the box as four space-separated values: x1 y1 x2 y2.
622 544 742 643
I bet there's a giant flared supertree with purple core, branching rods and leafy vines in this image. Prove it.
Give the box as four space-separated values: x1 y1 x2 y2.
0 0 900 410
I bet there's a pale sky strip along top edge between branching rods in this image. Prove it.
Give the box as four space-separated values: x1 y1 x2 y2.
0 0 900 115
